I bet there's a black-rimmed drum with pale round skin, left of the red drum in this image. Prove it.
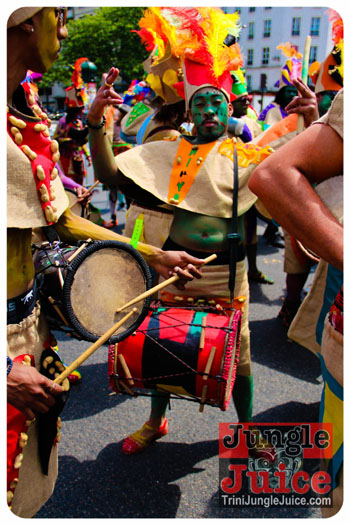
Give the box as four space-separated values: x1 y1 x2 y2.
34 241 152 343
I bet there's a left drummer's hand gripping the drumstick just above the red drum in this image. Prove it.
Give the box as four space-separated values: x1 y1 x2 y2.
152 250 203 290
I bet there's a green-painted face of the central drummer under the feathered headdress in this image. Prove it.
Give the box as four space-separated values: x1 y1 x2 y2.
191 88 228 140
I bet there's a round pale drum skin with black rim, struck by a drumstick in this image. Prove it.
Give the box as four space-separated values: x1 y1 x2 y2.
63 241 152 343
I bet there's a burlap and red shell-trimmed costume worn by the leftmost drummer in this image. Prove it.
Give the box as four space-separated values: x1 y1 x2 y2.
7 62 68 518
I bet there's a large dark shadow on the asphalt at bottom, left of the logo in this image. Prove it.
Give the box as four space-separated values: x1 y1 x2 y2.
37 440 218 518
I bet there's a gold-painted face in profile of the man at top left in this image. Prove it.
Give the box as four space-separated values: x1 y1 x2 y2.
36 7 67 72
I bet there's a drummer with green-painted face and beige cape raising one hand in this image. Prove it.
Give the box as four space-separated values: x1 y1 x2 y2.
88 46 271 454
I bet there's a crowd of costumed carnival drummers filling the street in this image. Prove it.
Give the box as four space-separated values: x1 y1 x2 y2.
7 7 343 518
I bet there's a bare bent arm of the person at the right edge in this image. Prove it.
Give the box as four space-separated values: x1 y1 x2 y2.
249 124 343 270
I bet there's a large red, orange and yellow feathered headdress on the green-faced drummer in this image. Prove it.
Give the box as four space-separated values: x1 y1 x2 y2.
138 7 243 102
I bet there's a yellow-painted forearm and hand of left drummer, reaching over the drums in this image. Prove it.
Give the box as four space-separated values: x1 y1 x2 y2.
55 208 203 289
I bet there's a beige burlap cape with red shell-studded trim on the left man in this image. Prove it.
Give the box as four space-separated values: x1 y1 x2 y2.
7 91 68 228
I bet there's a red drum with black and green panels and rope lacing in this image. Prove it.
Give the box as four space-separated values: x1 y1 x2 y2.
108 307 242 410
